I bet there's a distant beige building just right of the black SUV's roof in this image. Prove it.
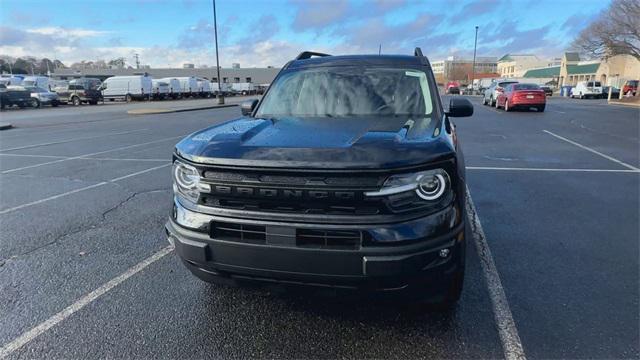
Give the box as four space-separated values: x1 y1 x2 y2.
431 56 498 83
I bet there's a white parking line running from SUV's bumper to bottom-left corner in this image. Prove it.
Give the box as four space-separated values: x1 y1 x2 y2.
0 245 173 359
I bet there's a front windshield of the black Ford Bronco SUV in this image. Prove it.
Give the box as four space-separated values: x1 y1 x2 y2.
256 67 433 117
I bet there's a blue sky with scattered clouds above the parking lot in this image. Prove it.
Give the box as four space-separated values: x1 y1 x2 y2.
0 0 609 67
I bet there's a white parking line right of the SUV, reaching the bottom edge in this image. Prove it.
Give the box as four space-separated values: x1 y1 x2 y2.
466 188 526 360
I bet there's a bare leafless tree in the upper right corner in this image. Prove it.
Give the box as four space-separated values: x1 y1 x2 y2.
574 0 640 60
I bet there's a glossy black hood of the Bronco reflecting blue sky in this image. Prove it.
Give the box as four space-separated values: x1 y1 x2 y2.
176 117 454 169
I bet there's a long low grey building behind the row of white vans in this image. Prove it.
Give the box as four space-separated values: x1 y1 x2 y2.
51 65 280 84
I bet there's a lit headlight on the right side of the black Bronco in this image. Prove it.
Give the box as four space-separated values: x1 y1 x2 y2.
365 169 451 201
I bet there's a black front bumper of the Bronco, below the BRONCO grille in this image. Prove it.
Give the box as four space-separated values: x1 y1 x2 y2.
166 203 465 296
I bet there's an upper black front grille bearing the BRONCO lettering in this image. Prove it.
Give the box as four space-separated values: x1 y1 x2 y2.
199 169 389 215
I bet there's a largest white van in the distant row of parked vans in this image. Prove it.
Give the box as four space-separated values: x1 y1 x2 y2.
100 75 153 102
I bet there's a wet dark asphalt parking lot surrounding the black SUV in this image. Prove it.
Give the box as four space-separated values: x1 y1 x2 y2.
0 97 640 359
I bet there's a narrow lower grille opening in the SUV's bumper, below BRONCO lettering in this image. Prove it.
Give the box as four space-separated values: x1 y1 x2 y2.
210 221 365 250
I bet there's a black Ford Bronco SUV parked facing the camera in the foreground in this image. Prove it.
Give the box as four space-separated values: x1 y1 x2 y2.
166 48 473 305
